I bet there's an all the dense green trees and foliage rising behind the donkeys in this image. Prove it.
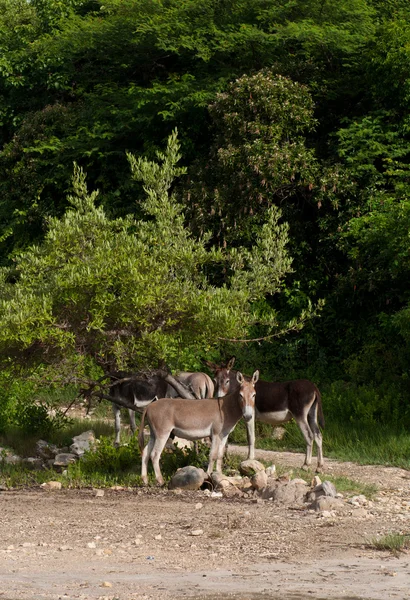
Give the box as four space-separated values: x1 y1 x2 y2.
0 0 410 460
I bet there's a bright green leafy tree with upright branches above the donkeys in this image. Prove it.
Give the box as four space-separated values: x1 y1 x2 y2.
0 133 290 378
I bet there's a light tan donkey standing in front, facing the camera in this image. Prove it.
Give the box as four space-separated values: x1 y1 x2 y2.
138 371 259 485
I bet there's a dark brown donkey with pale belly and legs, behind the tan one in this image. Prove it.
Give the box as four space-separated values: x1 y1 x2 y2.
206 357 325 471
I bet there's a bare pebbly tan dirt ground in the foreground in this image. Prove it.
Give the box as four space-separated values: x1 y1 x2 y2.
0 447 410 600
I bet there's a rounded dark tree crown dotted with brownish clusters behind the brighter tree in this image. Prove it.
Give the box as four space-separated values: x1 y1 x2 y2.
184 70 317 245
